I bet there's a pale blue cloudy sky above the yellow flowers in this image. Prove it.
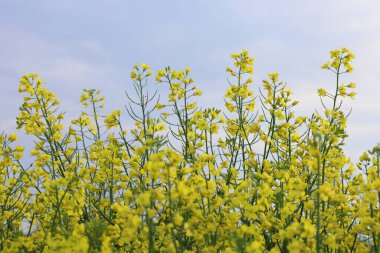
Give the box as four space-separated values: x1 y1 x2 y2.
0 0 380 159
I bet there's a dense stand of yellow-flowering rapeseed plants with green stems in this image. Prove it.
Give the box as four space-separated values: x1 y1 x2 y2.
0 48 380 253
